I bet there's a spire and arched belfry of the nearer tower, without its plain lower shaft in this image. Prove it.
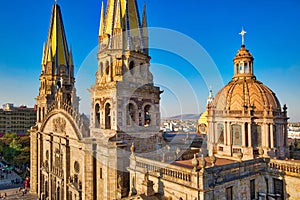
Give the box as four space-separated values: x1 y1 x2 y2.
90 0 161 138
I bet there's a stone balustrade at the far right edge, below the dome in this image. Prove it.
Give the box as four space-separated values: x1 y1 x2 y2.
268 159 300 177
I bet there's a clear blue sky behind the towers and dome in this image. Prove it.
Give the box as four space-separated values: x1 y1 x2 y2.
0 0 300 121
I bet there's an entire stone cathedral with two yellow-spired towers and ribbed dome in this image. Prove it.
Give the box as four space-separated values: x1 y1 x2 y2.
30 0 300 200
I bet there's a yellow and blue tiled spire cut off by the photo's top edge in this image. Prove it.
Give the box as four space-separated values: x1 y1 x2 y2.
99 0 148 54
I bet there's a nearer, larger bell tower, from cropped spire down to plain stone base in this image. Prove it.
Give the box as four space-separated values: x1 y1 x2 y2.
90 0 161 199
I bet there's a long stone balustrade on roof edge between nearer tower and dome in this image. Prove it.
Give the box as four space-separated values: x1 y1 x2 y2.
129 156 196 186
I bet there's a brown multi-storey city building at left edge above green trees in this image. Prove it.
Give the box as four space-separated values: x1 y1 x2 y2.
0 103 36 134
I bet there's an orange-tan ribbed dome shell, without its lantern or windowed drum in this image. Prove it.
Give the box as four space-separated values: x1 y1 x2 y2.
214 77 281 111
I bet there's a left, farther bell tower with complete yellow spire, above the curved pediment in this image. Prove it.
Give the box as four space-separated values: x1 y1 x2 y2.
36 3 79 123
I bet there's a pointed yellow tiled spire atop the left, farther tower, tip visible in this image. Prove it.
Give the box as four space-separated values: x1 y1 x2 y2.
42 3 69 75
